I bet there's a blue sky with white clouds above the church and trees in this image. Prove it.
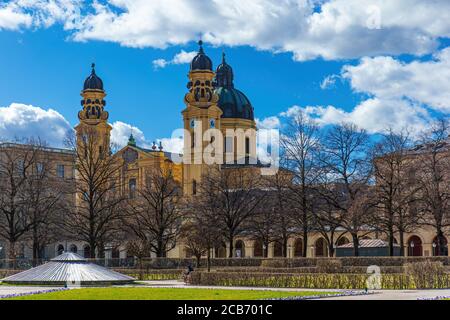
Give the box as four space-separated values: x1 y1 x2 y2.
0 0 450 151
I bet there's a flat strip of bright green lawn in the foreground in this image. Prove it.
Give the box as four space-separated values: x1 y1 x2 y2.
7 288 334 300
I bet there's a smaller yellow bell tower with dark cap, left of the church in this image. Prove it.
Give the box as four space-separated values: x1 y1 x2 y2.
75 63 112 156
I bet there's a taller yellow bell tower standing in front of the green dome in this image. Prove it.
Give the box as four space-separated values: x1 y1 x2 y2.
182 41 222 195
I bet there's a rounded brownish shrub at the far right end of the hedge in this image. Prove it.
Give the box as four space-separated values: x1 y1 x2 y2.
404 260 447 289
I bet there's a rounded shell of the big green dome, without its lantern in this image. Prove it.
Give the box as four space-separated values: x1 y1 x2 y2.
215 87 254 120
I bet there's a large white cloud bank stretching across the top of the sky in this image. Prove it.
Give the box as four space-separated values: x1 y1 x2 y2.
0 0 450 60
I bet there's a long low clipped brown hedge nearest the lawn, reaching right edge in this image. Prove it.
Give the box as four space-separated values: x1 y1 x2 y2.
191 272 450 290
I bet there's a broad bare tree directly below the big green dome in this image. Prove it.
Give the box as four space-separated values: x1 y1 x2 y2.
199 166 265 258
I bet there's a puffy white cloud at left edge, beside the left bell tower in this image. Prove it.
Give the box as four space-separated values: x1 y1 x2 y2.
0 103 72 147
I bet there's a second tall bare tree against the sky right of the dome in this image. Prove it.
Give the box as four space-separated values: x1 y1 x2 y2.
319 124 374 256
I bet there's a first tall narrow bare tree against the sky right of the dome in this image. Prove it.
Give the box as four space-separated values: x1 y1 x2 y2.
281 112 320 257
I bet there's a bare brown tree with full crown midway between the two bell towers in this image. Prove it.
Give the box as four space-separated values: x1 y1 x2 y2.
125 167 183 257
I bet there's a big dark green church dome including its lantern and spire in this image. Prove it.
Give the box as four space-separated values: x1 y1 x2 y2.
215 54 255 121
